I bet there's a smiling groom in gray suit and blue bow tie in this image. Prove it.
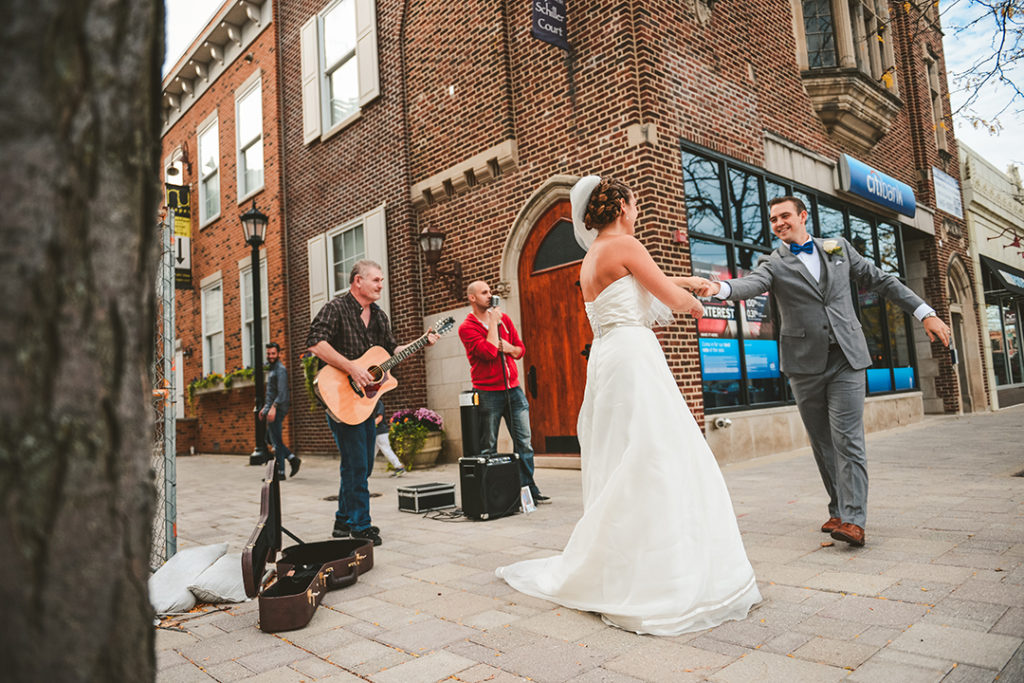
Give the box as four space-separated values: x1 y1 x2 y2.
697 197 949 546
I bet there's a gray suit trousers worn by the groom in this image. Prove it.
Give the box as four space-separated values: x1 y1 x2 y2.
787 346 867 528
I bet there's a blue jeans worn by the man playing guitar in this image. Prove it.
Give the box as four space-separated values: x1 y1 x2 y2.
327 418 377 531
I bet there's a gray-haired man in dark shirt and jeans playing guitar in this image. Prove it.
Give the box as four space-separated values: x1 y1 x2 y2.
306 259 437 546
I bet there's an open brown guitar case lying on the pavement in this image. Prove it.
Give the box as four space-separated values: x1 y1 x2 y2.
242 459 374 633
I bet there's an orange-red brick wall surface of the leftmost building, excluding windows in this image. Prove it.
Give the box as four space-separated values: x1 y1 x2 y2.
162 23 294 455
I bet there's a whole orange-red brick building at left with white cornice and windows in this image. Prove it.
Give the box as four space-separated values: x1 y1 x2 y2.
163 0 292 454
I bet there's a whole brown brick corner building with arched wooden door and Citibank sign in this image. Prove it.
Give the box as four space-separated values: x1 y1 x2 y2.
278 0 984 466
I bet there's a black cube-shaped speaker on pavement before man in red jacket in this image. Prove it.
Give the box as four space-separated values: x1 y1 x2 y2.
459 453 521 519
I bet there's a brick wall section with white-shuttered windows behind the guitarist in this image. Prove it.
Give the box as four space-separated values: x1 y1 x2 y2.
275 0 426 454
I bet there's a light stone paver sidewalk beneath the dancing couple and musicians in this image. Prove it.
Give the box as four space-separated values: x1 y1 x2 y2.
157 407 1024 683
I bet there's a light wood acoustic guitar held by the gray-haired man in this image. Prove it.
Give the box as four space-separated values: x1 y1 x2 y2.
313 315 455 425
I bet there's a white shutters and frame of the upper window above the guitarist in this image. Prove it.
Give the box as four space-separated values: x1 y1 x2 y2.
300 0 380 144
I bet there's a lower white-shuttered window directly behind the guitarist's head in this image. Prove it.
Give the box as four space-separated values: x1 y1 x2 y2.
306 204 390 318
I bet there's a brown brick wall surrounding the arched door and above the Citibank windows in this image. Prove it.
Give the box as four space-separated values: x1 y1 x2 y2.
397 0 966 419
